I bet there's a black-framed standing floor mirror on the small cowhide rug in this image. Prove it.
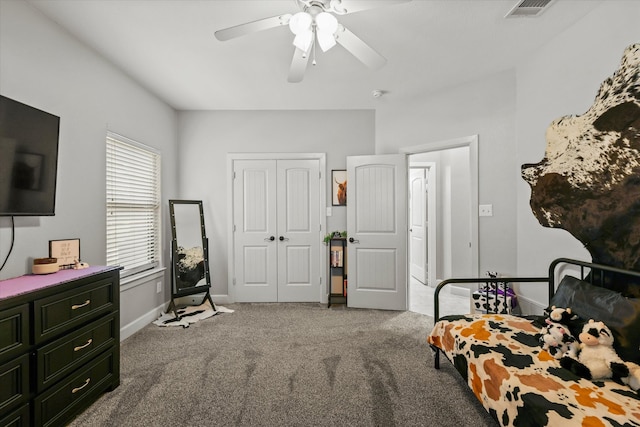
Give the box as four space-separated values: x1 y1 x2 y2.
167 200 216 317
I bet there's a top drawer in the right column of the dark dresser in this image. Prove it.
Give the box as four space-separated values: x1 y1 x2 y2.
34 279 119 344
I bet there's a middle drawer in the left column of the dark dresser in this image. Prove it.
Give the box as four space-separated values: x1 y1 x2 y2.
0 354 29 413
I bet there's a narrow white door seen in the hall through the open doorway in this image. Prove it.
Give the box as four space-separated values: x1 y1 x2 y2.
409 168 427 284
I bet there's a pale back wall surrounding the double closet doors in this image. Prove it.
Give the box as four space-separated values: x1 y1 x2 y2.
178 110 375 295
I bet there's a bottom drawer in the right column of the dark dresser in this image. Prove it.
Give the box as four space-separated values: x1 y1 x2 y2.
33 349 119 426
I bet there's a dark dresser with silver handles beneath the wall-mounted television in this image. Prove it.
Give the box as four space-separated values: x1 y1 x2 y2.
0 267 120 427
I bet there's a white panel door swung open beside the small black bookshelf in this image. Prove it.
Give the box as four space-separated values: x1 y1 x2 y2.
347 154 408 310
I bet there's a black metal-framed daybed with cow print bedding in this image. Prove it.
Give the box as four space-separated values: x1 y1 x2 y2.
427 259 640 427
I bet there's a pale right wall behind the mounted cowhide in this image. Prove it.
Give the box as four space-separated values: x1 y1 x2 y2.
513 0 640 310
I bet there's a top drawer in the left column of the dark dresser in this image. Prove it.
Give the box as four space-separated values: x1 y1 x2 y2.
0 304 29 363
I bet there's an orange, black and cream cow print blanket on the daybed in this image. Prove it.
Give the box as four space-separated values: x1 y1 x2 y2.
427 314 640 427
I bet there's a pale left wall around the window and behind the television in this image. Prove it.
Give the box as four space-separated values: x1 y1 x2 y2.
0 1 177 338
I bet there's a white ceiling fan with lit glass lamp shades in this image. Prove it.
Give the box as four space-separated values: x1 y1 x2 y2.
215 0 411 83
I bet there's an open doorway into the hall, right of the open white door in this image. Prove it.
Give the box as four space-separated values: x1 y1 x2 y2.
401 135 478 314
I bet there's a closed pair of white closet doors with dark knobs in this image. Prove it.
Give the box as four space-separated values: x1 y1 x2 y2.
233 159 321 302
